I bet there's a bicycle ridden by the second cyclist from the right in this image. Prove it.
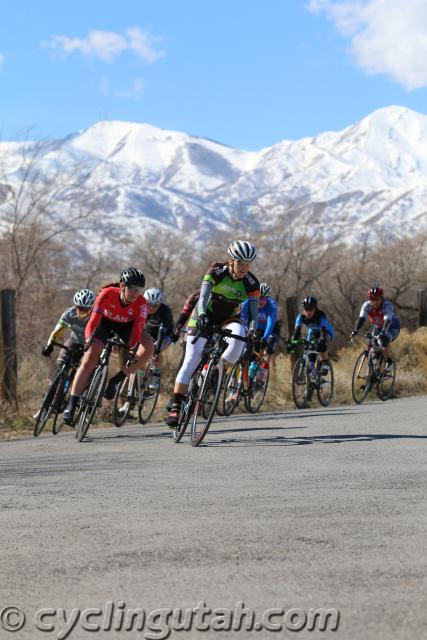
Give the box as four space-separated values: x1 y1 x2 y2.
291 339 334 409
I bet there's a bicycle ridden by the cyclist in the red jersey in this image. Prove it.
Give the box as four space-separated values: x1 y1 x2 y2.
76 334 128 442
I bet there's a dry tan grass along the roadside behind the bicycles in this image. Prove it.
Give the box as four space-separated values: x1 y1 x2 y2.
0 327 427 438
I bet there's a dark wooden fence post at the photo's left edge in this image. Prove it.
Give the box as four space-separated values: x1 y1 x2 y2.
0 289 18 402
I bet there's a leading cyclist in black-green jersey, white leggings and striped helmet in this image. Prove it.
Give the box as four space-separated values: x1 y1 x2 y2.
166 240 259 428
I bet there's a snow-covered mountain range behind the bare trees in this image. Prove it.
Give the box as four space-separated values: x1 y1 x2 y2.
0 107 427 246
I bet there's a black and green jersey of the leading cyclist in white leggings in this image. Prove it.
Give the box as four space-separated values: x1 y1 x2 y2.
188 262 260 327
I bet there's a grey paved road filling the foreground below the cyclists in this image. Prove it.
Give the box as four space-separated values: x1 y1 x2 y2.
0 397 427 640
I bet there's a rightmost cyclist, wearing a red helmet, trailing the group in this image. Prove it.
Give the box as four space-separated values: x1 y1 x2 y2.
351 287 400 364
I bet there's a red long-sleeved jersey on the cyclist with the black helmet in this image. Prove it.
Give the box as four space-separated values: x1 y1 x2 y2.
85 286 149 348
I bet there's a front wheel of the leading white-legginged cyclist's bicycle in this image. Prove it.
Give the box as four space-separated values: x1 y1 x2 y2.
190 360 224 447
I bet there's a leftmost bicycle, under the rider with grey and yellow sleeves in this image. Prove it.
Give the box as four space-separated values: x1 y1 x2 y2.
33 340 83 438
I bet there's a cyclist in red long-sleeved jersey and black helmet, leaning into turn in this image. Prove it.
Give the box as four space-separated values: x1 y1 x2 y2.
64 267 153 424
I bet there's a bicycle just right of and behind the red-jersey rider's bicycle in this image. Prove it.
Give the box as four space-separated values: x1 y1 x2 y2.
113 324 166 427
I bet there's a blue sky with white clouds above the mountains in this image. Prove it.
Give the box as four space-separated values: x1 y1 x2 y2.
0 0 427 150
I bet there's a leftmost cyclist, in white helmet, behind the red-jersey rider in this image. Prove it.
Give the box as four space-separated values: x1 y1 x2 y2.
42 289 95 365
